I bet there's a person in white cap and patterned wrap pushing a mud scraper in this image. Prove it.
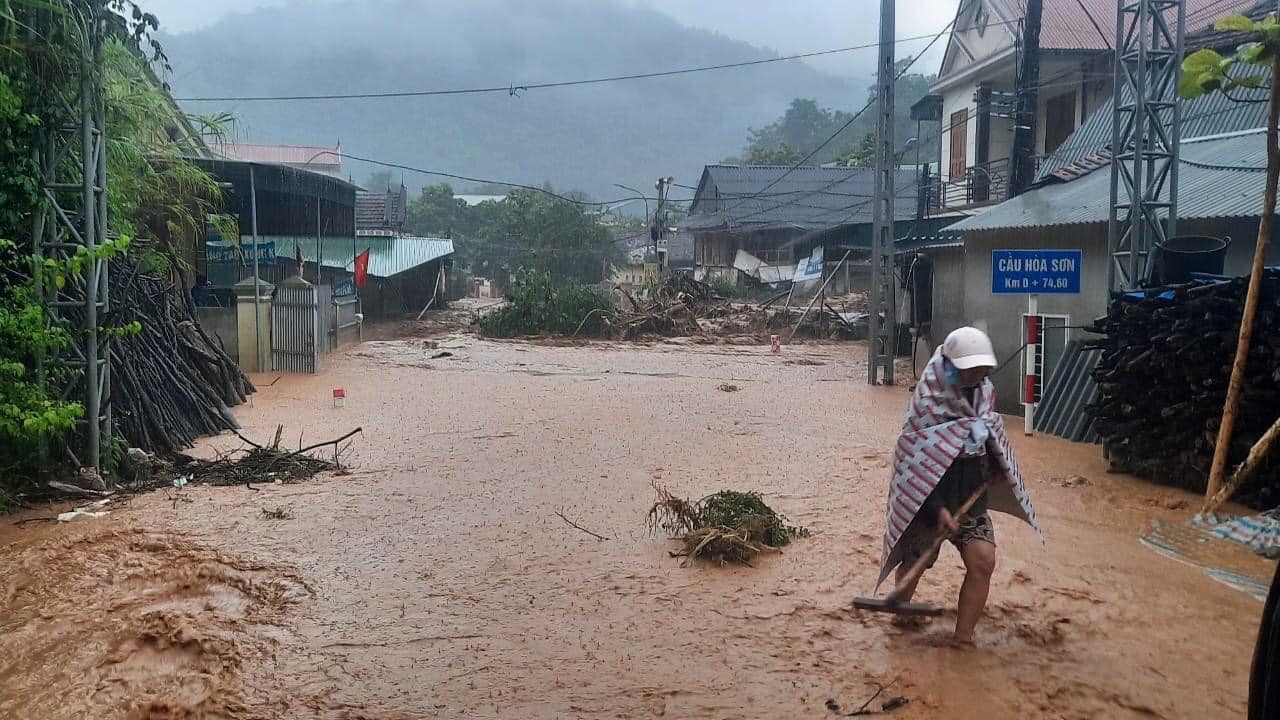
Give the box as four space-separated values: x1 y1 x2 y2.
879 328 1039 644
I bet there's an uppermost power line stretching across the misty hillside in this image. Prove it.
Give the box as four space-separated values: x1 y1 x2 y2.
174 23 983 102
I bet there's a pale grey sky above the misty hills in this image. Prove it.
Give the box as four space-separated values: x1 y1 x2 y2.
140 0 957 78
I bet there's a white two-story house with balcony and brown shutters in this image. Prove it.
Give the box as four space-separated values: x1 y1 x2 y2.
929 0 1256 213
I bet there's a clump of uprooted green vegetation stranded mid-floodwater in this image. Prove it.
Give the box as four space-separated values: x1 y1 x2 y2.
646 483 809 566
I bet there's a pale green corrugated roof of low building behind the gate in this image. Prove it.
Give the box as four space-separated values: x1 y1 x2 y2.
249 236 453 278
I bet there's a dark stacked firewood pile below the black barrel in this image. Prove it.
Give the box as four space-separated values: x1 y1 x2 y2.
1088 270 1280 507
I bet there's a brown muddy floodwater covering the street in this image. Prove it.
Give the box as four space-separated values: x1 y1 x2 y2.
0 337 1266 720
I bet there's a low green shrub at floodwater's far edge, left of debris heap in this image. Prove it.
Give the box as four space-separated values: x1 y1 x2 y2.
479 270 617 337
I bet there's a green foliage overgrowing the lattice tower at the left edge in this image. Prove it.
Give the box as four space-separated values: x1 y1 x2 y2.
0 0 220 486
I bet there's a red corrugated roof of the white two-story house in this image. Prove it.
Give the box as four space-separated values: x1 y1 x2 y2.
991 0 1258 50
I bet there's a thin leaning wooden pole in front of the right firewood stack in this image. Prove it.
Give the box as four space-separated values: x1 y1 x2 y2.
1204 58 1280 500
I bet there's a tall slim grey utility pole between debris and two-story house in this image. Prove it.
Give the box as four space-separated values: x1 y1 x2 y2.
867 0 897 386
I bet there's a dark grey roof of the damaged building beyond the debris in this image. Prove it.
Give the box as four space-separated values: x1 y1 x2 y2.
681 165 916 231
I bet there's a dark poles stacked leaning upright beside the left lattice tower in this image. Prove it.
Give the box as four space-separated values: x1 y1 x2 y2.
110 259 253 452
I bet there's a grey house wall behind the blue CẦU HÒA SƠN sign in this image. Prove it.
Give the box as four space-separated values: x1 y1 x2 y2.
925 219 1280 415
